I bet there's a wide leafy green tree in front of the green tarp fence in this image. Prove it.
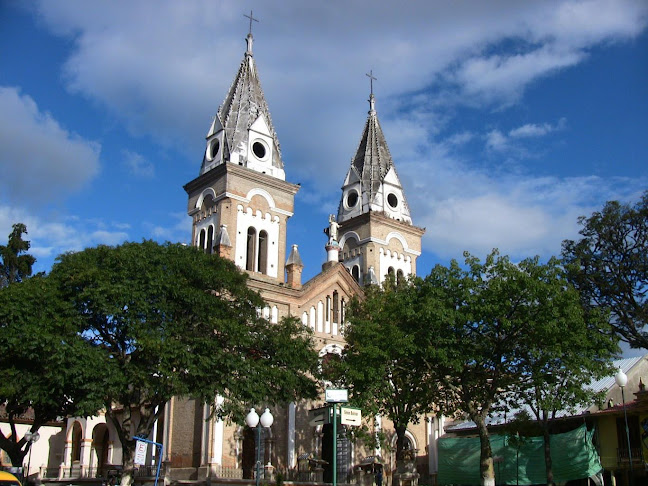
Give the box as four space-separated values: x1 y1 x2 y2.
421 250 616 482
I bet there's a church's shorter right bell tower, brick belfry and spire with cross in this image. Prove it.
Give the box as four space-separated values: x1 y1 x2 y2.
337 77 425 285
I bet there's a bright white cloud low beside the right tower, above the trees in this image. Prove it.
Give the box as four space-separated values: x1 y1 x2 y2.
401 162 648 259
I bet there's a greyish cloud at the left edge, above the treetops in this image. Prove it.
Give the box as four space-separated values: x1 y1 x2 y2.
0 87 100 205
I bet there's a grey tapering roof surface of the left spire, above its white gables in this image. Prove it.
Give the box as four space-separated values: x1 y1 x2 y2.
201 28 283 173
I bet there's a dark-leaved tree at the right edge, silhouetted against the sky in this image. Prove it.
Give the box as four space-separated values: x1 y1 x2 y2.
563 191 648 349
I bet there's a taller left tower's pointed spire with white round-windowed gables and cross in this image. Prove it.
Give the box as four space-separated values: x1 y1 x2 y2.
200 11 286 180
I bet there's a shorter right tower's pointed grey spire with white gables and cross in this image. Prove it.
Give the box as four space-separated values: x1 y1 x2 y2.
337 72 412 224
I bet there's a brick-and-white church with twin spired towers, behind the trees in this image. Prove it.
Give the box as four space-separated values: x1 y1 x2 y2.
53 25 443 484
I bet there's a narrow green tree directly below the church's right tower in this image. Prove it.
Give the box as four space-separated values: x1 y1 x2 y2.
340 279 434 463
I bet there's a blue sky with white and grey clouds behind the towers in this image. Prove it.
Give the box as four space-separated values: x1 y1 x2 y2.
0 0 648 284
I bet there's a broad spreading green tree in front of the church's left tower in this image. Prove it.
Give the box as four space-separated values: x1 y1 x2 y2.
51 241 317 485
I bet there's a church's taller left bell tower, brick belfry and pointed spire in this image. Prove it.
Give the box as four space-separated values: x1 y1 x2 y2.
184 26 299 283
